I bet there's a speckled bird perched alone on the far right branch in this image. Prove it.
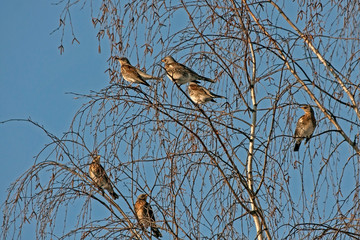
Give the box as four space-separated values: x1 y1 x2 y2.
294 105 316 152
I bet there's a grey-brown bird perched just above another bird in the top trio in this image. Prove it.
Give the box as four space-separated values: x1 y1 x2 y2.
161 56 215 85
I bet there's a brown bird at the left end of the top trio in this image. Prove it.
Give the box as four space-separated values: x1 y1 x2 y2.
116 57 161 86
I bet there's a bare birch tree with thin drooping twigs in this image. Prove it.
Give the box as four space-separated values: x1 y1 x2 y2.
3 0 360 239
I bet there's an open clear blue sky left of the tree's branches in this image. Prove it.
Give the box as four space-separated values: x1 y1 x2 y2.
0 0 108 233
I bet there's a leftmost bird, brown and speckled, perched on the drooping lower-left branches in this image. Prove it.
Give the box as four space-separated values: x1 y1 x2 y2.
89 155 119 199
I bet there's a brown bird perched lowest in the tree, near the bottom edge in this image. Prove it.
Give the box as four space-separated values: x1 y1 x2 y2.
134 193 162 238
